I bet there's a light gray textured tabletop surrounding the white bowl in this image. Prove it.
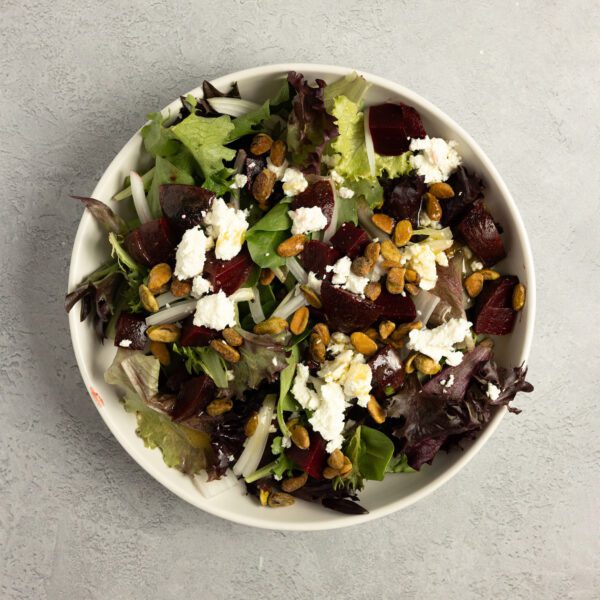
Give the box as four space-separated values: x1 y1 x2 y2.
0 0 600 600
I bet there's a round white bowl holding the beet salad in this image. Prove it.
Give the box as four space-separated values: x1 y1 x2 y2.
69 64 535 530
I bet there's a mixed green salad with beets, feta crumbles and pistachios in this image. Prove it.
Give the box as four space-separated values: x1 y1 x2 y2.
65 72 533 514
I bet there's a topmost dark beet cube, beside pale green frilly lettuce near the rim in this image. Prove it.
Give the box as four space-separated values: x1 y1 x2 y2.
367 102 426 156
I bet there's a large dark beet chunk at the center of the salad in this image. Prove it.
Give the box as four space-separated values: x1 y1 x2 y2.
321 281 380 333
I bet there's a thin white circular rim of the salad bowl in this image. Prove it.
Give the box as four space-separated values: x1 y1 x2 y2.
68 63 536 531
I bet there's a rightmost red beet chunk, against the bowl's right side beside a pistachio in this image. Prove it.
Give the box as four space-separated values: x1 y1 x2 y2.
473 275 519 335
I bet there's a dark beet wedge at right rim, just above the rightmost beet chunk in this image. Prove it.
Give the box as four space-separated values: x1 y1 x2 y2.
457 200 506 267
